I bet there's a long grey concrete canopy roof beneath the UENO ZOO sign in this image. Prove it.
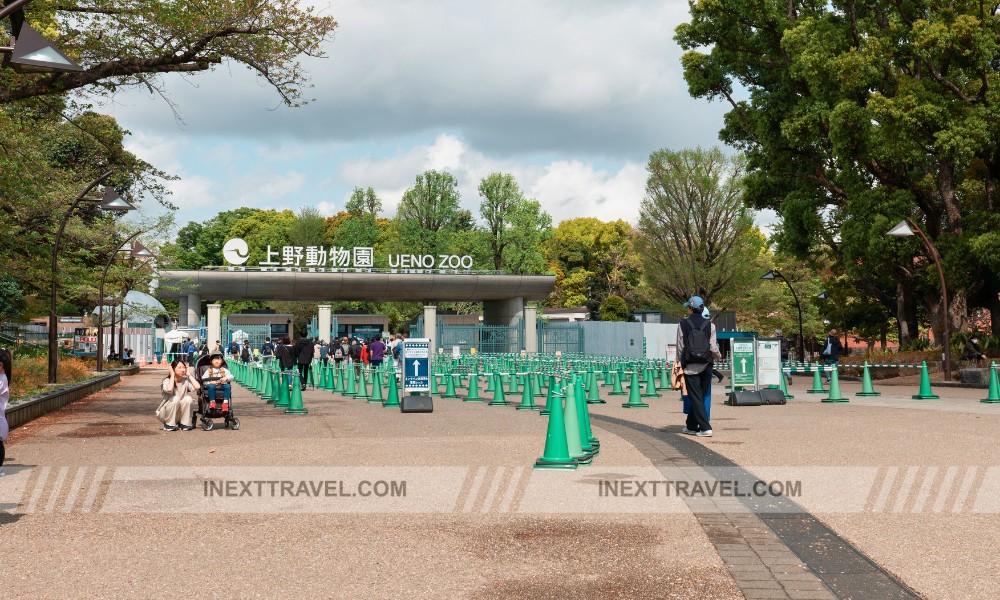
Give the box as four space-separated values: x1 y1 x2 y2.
158 267 556 302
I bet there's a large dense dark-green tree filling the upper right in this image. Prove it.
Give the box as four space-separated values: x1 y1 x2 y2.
676 0 1000 341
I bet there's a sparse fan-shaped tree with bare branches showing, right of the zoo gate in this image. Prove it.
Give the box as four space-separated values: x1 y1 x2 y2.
638 148 765 304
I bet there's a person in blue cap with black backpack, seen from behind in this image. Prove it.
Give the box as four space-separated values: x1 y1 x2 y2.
677 296 722 437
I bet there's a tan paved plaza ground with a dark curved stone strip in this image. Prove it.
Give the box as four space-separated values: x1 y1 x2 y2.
0 368 1000 599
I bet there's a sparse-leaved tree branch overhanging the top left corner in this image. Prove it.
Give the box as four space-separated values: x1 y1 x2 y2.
0 0 336 106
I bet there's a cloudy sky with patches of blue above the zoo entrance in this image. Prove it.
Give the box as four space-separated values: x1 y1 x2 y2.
102 0 748 232
